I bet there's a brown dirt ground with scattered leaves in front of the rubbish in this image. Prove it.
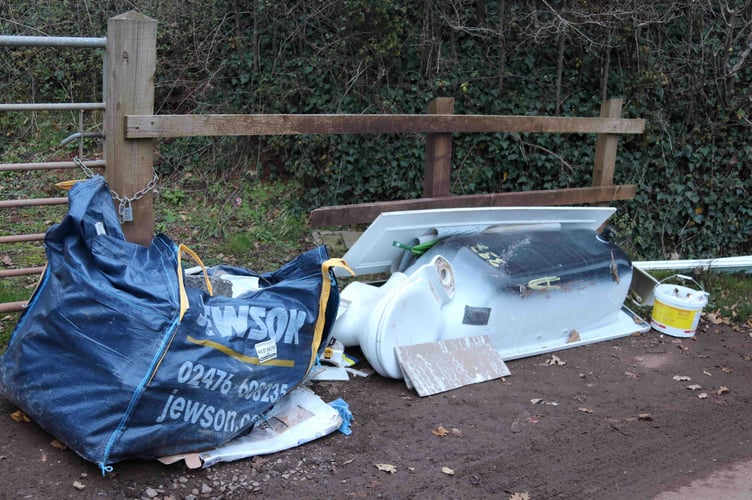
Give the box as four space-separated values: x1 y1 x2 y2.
0 320 752 499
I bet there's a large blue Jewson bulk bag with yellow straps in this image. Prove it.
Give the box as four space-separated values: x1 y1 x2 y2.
0 176 344 472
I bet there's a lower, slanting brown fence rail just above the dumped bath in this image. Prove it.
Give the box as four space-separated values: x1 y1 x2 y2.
310 184 637 227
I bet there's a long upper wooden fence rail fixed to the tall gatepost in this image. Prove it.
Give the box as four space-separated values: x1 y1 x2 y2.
125 112 645 139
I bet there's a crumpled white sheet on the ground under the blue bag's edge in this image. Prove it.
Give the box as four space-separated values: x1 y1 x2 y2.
159 387 342 469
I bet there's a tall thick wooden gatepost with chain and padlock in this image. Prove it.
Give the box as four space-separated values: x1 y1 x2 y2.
104 11 157 245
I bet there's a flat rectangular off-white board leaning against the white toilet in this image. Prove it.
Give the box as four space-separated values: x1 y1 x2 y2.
395 335 511 397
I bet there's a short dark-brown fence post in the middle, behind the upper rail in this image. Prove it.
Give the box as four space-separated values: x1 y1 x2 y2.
423 97 454 198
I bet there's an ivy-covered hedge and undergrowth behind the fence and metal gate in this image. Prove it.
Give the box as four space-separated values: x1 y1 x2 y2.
0 0 752 264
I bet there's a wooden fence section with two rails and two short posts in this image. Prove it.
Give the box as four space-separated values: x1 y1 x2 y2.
125 98 645 229
